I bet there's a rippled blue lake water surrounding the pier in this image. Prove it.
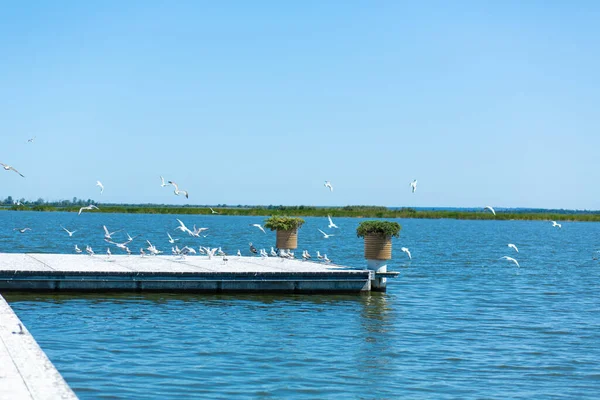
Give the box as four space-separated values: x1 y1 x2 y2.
0 211 600 399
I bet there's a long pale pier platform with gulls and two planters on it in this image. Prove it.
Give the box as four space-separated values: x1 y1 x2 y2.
0 253 375 293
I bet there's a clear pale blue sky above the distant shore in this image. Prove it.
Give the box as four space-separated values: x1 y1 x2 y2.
0 0 600 210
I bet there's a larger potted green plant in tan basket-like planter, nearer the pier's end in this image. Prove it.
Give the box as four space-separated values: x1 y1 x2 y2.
356 220 402 260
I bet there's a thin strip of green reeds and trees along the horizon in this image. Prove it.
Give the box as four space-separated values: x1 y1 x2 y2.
2 204 600 222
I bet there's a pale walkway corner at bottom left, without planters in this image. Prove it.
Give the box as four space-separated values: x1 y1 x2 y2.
0 296 77 400
